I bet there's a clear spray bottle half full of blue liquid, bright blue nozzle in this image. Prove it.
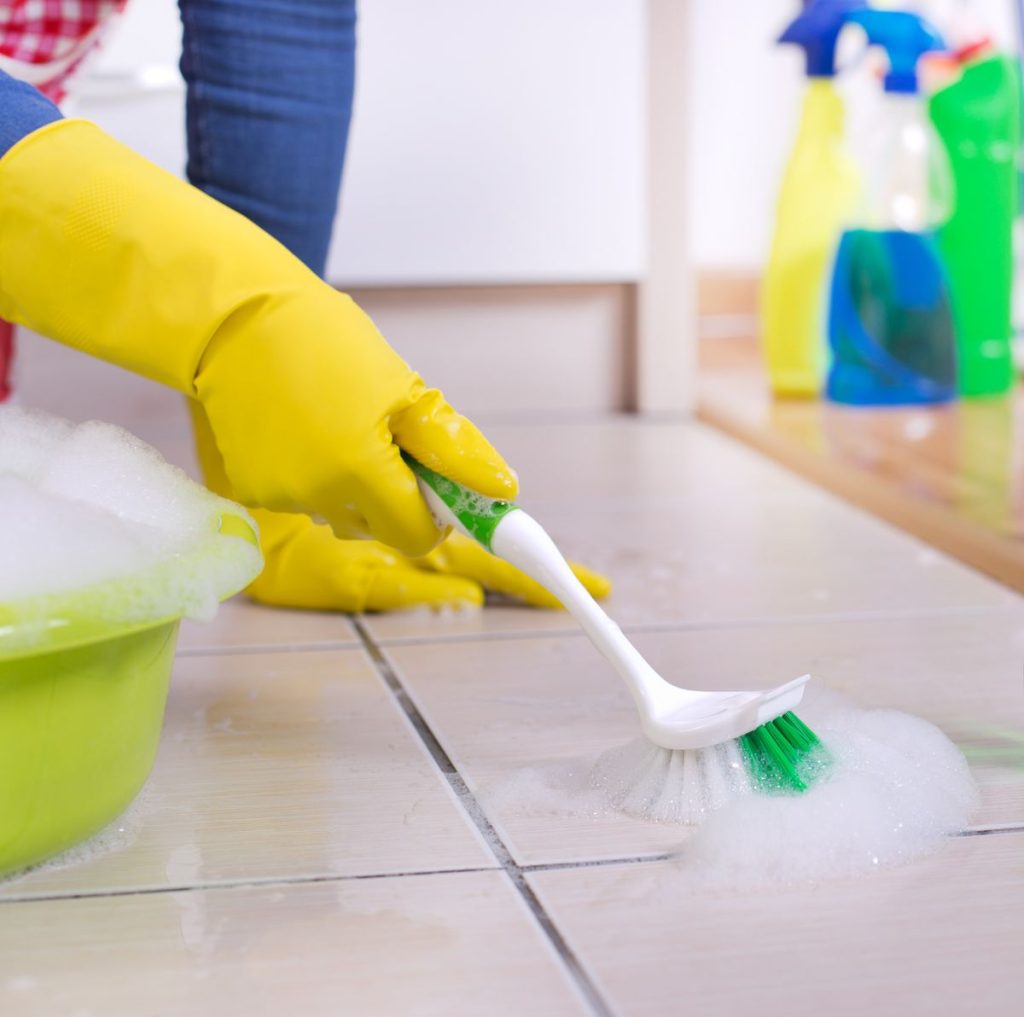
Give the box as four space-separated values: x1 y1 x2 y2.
826 10 956 406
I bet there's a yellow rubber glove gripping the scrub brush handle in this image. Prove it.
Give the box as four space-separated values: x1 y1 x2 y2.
0 120 517 555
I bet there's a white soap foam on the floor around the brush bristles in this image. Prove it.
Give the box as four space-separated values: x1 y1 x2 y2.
483 690 978 888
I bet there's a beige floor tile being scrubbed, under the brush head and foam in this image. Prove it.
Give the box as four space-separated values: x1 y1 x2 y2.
388 611 1024 864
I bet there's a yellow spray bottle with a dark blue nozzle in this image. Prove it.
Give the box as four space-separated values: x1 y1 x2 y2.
761 0 866 396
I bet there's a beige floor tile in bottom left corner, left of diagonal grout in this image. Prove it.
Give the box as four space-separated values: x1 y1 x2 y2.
0 873 587 1017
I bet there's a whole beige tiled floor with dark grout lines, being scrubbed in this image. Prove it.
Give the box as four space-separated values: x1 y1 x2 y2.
0 420 1024 1017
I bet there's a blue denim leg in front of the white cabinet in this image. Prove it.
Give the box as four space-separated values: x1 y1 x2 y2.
178 0 355 274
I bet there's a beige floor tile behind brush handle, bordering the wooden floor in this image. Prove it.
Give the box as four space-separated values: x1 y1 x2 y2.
358 422 1013 641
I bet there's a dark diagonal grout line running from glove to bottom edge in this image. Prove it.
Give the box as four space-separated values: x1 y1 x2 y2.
353 618 612 1017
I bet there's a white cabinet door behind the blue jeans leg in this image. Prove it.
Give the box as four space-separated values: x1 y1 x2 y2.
76 0 645 286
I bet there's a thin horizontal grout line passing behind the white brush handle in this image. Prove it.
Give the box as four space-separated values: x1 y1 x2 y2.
362 604 1015 647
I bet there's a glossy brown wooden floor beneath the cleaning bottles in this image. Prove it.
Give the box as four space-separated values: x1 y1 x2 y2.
697 329 1024 591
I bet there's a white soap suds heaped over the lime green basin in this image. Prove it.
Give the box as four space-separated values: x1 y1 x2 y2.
0 407 259 647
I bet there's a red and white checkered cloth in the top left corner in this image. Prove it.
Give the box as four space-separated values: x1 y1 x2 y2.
0 0 128 101
